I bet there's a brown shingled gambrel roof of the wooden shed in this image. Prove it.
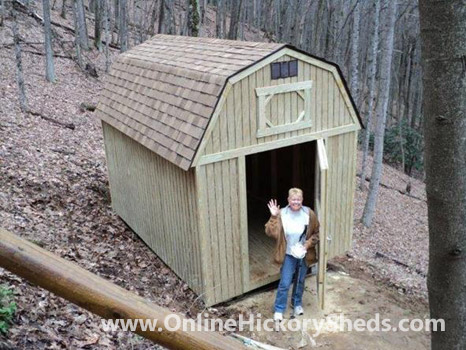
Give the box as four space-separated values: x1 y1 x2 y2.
97 34 360 170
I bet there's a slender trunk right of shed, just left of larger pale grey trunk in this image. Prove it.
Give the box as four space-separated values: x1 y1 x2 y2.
359 0 380 190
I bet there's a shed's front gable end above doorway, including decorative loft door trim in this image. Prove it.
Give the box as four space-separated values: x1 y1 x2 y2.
194 48 360 160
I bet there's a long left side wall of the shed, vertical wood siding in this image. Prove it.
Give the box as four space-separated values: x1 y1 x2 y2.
102 123 203 294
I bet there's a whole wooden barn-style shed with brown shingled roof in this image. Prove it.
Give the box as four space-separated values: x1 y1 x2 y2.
97 35 361 305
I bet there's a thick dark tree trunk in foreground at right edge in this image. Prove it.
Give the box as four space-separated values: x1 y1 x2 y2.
419 0 466 350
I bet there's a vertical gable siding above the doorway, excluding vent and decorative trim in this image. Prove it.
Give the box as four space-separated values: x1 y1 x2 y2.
199 55 353 155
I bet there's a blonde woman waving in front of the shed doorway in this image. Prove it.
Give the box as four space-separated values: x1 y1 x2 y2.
265 188 319 321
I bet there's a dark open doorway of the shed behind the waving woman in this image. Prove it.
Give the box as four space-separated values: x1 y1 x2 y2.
246 141 316 289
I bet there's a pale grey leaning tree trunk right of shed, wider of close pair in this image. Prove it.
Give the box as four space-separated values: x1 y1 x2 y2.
362 0 396 227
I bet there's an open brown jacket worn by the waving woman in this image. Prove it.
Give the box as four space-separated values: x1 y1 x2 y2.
265 209 320 266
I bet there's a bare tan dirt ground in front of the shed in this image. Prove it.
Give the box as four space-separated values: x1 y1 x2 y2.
228 261 430 350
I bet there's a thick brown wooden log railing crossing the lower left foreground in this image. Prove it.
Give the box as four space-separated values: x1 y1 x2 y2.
0 228 246 350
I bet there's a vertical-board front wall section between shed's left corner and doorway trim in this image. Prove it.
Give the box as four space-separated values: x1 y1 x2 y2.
196 159 247 305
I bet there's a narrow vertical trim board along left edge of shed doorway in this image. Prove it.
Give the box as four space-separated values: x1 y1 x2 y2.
237 156 250 292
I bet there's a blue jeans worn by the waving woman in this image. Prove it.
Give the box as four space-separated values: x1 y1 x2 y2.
275 254 307 313
